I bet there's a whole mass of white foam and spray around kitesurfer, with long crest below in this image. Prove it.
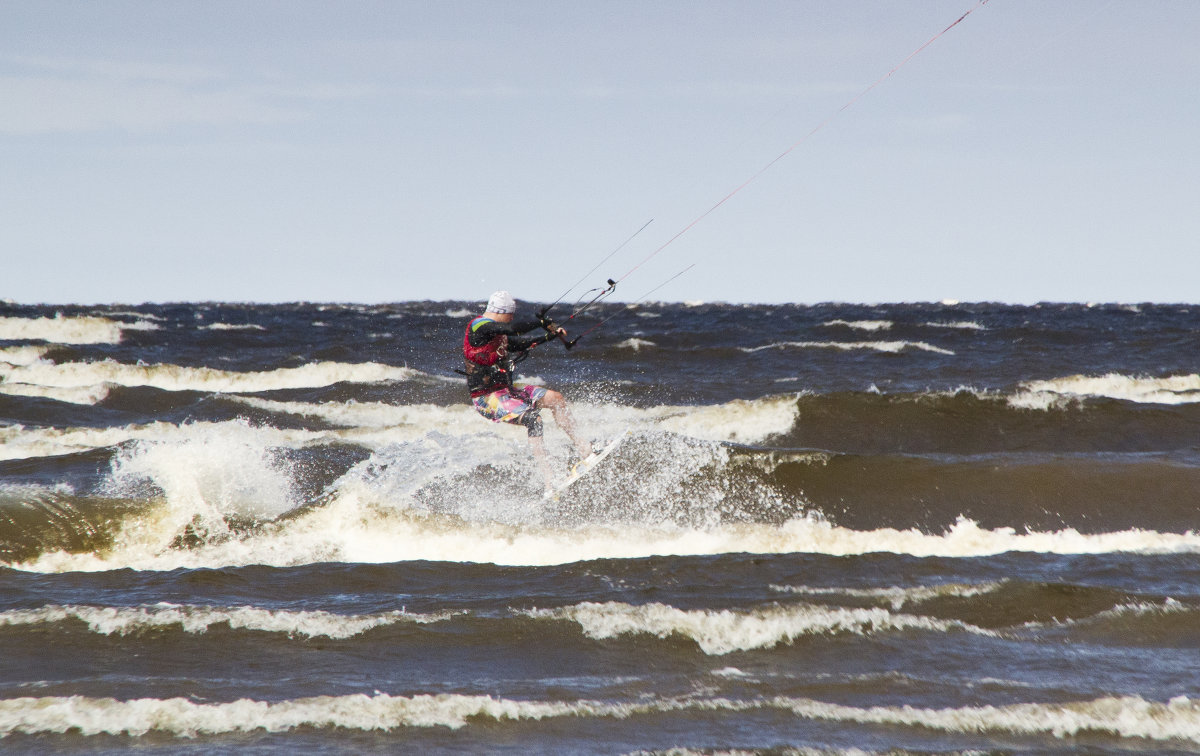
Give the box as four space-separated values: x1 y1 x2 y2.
9 396 1200 571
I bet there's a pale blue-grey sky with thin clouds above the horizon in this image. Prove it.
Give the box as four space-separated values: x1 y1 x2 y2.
0 0 1200 304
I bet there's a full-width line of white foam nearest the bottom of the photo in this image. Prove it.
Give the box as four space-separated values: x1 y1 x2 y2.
0 691 1200 743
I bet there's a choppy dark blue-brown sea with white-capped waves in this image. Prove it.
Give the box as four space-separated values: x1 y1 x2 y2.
0 301 1200 755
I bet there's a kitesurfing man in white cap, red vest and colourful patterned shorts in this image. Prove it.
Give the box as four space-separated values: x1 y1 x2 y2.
462 290 592 488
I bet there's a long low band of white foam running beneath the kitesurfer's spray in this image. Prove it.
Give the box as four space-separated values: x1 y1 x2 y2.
10 504 1200 572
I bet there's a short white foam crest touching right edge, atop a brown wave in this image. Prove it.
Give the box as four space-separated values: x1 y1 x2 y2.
1009 373 1200 409
